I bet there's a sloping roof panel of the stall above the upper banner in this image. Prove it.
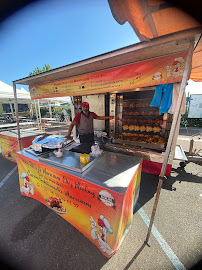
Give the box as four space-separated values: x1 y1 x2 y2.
14 27 202 85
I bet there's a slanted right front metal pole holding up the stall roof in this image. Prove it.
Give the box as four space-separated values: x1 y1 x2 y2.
145 41 194 243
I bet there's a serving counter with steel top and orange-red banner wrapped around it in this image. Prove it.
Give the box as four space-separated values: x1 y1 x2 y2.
17 144 141 257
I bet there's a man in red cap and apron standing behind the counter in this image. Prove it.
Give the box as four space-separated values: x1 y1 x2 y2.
66 102 113 144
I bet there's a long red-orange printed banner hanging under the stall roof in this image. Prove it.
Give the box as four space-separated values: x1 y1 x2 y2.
29 52 187 99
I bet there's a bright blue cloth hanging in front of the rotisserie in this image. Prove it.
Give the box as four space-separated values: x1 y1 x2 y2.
150 83 173 114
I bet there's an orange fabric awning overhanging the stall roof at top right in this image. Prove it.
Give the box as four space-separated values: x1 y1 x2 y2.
108 0 202 82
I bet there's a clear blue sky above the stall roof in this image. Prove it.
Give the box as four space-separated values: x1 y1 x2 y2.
0 0 202 94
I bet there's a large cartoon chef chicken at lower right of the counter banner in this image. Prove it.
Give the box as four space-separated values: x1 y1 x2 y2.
89 215 113 255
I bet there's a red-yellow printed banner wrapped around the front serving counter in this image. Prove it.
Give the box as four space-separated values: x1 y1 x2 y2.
17 153 141 257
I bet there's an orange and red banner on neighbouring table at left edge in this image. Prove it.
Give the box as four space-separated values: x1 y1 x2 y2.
0 134 36 162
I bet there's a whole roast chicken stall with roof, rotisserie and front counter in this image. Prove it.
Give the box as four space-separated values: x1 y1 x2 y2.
13 28 201 257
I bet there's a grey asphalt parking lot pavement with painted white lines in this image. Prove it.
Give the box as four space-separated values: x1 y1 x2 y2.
0 155 202 270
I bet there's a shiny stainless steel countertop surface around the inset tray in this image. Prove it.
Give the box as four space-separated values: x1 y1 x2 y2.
18 150 141 193
